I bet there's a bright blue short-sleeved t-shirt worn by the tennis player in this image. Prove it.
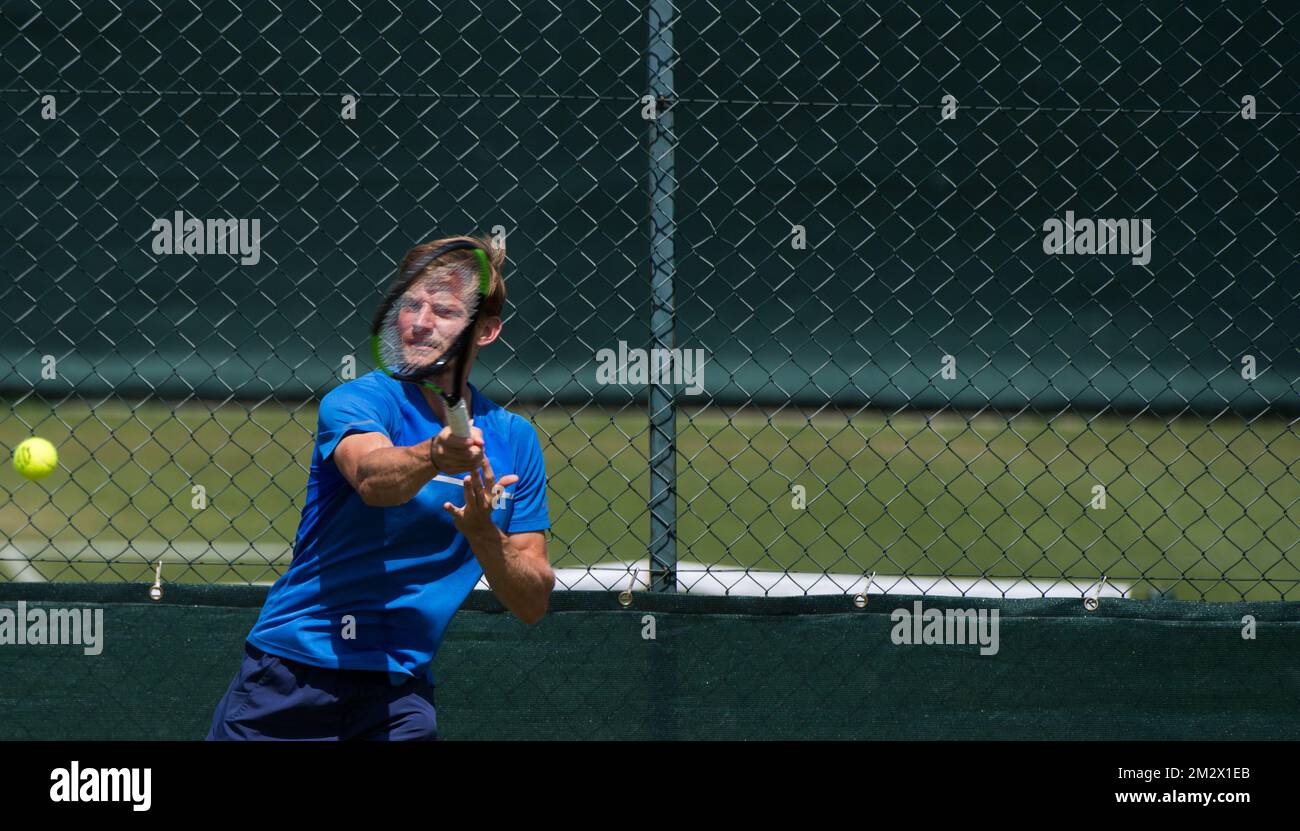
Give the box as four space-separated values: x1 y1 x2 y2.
248 371 550 680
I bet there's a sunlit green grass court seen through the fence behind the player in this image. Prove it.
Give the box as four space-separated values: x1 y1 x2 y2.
0 402 1300 601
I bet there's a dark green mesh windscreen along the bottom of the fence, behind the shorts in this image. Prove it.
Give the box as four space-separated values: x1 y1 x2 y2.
0 585 1300 740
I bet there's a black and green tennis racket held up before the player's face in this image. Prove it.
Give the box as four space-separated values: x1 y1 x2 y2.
371 242 491 438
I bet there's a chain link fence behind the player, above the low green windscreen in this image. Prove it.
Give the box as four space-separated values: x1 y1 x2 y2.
0 0 1300 600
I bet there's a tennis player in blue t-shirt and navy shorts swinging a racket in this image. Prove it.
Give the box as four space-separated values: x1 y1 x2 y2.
208 237 555 741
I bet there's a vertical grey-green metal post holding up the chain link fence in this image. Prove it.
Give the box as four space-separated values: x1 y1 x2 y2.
646 0 677 592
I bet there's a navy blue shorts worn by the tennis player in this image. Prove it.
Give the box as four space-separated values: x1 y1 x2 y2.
208 644 438 741
